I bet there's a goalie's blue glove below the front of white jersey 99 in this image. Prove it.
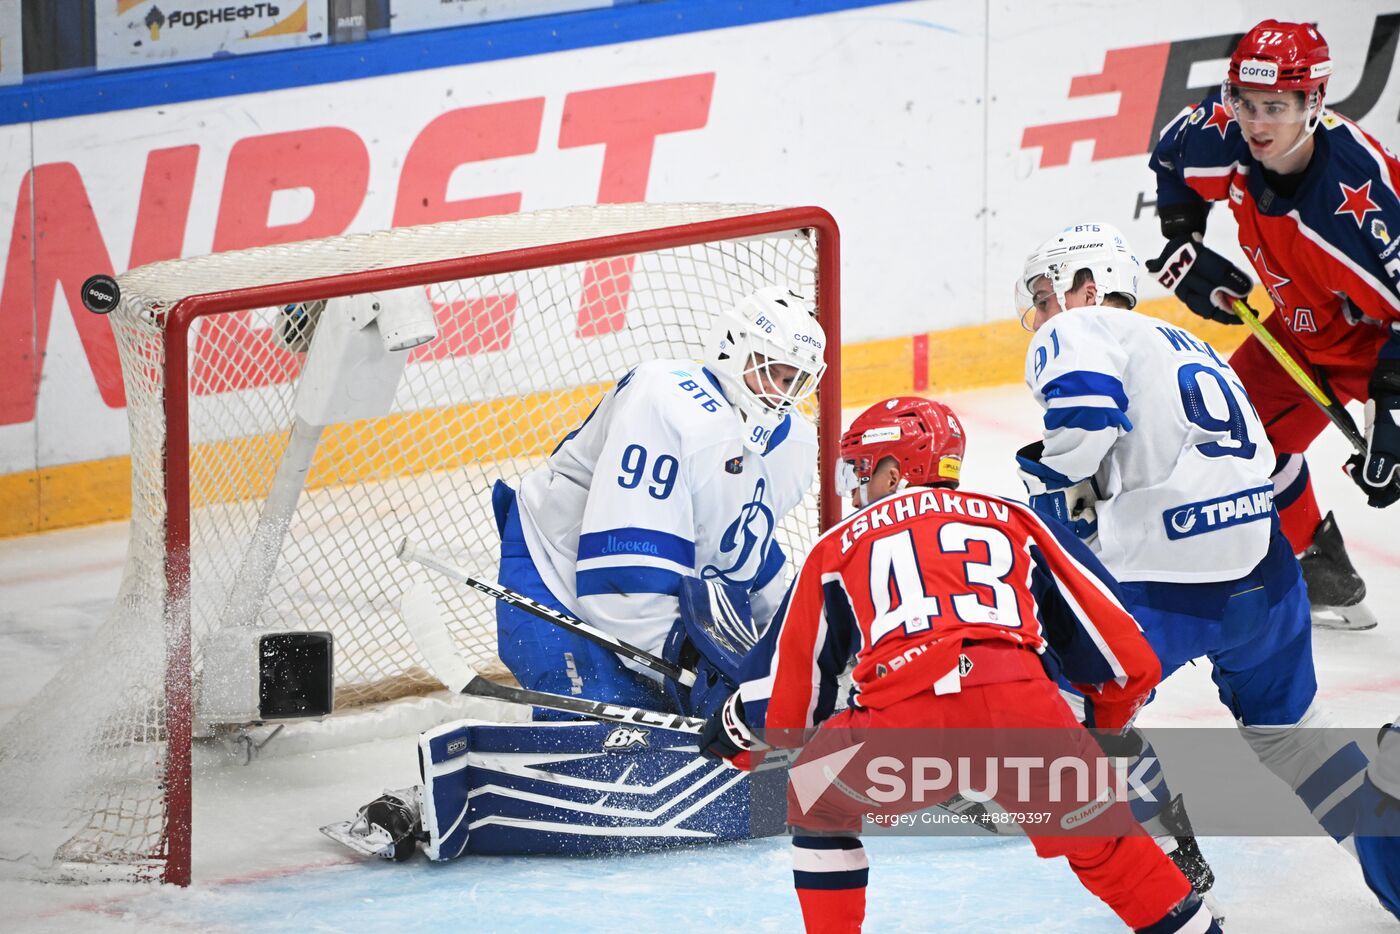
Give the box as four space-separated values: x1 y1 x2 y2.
661 577 760 717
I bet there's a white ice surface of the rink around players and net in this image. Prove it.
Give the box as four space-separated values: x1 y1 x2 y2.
0 386 1400 934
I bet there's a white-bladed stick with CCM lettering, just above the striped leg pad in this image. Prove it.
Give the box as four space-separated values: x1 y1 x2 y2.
399 581 704 734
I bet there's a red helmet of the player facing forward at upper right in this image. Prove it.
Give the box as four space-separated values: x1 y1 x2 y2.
1221 20 1331 158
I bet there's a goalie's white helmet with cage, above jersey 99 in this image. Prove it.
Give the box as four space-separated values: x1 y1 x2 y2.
704 286 826 452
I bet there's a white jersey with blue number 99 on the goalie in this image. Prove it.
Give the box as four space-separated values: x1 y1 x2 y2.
518 360 816 654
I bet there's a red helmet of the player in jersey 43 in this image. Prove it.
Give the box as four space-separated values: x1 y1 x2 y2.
836 396 967 506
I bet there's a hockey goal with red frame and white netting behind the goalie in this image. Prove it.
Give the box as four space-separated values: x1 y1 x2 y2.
0 204 840 884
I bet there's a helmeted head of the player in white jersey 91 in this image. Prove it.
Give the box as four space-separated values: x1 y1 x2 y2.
1016 223 1142 330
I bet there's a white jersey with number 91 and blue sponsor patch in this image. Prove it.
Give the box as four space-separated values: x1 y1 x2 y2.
1026 305 1274 583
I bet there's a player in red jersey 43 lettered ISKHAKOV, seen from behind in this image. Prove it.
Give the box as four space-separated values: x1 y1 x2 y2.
700 398 1221 934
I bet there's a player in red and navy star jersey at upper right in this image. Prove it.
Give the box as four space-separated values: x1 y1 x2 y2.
1147 20 1400 629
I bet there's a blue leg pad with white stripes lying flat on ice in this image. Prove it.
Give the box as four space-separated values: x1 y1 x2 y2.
419 720 787 860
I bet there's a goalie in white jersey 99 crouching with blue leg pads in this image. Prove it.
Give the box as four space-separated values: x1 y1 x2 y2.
322 287 826 860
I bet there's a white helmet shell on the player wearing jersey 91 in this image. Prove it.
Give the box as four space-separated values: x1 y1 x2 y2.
1016 224 1142 330
